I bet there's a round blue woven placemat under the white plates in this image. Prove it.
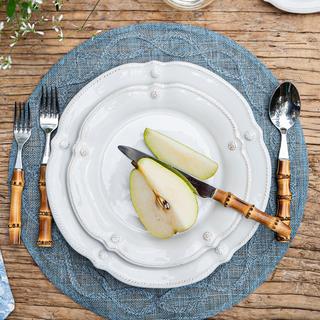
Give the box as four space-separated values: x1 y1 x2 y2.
9 24 308 320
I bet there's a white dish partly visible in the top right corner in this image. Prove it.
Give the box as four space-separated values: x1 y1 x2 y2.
264 0 320 13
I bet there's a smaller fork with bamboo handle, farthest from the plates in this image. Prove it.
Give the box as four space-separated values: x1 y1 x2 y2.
8 103 31 244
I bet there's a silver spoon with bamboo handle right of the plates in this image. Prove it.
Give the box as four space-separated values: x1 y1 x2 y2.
269 81 301 242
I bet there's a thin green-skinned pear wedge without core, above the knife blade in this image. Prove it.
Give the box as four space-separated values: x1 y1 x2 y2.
144 128 218 180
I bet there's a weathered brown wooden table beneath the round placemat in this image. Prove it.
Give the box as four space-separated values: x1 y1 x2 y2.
0 0 320 320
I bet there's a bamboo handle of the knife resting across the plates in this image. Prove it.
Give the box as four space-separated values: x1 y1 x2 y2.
213 189 291 241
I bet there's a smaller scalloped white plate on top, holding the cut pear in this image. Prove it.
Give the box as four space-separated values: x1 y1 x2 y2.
67 83 251 268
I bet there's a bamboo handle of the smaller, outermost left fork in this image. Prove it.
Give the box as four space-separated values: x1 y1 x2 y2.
8 169 24 244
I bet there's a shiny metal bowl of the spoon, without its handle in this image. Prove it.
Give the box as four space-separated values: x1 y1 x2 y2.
269 81 301 133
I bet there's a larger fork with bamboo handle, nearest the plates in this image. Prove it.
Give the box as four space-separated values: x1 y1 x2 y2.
37 87 59 247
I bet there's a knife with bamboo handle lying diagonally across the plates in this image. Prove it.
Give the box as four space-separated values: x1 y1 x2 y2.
118 146 291 241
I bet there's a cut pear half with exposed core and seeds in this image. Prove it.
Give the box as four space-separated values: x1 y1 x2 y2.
130 158 198 239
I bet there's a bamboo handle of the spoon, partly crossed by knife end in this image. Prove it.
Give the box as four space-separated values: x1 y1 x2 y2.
276 159 292 242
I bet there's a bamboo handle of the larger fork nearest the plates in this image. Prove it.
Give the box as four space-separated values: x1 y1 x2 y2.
37 164 53 247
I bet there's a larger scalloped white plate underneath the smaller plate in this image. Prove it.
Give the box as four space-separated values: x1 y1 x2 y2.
47 61 271 288
